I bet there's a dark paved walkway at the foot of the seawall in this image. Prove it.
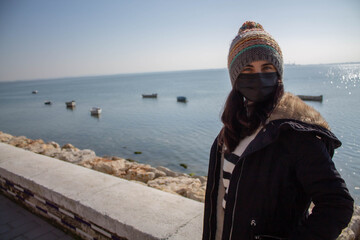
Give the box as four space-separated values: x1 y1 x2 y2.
0 193 74 240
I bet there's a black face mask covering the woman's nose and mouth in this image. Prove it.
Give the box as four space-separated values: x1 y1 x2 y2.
235 72 279 102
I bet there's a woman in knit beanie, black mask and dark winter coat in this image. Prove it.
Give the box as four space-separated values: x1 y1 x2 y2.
203 22 353 240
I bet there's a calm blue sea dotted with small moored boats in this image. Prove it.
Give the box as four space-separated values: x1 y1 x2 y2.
0 63 360 204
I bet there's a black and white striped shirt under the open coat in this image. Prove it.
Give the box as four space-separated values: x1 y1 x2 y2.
222 127 261 209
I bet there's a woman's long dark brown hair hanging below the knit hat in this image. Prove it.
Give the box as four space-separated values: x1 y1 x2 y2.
219 80 284 152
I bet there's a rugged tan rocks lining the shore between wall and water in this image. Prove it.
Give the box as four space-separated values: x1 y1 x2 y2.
0 131 360 240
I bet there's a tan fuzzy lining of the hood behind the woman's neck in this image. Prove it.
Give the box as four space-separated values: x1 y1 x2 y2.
269 92 330 130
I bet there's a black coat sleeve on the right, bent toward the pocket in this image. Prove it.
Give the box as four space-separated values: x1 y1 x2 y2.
290 133 354 240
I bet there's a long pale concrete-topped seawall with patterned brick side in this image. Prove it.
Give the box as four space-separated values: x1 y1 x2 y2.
0 143 204 240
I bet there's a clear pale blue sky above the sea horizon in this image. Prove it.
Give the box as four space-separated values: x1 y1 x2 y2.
0 0 360 81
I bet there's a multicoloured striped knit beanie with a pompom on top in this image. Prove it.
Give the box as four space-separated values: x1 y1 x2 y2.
228 21 283 85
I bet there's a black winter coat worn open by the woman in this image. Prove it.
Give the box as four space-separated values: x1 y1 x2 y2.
203 119 353 240
